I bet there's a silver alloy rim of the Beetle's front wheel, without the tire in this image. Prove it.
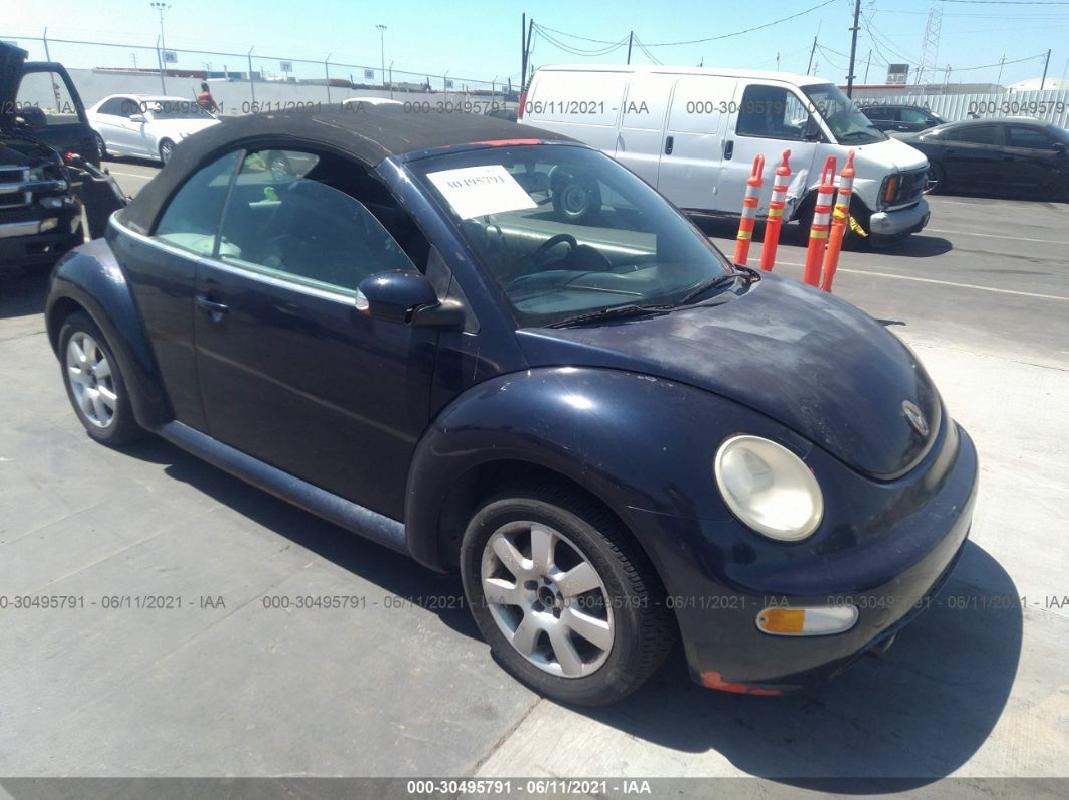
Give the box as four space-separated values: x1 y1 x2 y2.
481 522 616 678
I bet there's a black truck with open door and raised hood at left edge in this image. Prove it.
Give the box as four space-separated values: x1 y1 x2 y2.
0 42 124 267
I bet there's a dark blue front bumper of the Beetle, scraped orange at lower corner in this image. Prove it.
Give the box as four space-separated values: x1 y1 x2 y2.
624 419 977 694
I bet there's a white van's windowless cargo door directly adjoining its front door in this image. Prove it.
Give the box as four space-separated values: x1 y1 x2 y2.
657 75 735 211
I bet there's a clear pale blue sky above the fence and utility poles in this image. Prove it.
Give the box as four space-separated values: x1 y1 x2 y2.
0 0 1069 83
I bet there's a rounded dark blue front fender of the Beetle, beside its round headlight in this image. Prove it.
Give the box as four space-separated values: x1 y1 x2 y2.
405 367 810 568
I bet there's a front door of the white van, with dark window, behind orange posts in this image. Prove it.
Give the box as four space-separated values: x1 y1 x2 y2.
721 82 816 214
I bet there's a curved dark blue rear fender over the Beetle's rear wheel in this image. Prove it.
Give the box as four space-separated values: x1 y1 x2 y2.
45 239 173 429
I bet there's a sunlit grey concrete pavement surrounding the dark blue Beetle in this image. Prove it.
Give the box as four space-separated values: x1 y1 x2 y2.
0 161 1069 797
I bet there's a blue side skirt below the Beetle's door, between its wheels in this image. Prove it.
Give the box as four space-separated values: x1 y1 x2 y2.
157 421 408 555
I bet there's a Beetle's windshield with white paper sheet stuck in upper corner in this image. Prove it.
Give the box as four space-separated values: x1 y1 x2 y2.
409 144 731 327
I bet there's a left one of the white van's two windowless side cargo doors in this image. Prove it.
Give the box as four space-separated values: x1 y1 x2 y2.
616 73 676 187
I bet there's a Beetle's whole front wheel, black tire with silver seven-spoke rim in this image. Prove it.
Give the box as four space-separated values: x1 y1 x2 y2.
461 488 676 706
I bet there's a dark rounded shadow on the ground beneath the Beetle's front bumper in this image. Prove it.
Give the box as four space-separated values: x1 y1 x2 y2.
583 542 1022 794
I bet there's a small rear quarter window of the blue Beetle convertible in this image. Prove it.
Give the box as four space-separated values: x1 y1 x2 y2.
153 151 242 256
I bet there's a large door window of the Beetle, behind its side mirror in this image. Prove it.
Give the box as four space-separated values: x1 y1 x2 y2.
218 150 415 292
